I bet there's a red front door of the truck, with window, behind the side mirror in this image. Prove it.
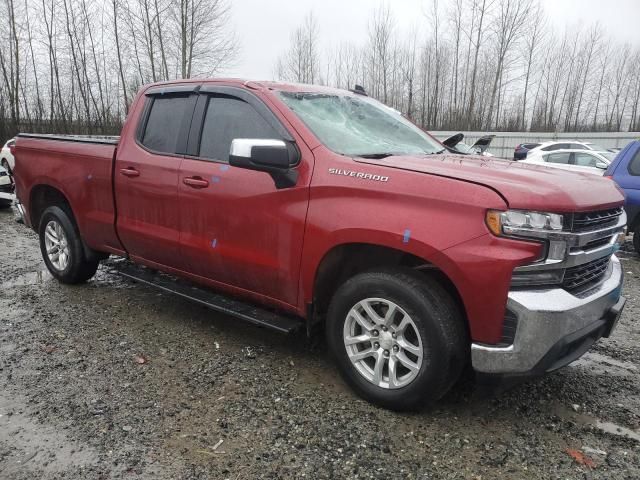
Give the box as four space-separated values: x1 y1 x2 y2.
178 87 313 305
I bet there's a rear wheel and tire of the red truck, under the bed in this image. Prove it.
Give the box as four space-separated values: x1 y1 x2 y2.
38 206 99 284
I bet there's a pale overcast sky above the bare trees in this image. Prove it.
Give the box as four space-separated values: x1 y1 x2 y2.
227 0 640 80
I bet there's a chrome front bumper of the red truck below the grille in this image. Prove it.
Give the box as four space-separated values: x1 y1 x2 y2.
471 255 625 376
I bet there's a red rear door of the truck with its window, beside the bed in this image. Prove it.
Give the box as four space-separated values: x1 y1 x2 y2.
114 86 197 269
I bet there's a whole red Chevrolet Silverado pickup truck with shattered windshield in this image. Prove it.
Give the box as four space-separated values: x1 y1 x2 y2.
15 80 626 409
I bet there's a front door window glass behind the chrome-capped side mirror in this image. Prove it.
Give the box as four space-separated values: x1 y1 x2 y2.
200 97 280 162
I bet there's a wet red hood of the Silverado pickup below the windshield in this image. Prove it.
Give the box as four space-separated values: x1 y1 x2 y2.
354 154 624 212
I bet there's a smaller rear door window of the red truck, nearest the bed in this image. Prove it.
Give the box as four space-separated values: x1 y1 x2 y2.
140 95 190 154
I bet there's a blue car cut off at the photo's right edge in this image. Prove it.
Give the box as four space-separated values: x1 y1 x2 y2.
605 140 640 253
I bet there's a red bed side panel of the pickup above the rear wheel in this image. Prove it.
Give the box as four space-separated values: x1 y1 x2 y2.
15 137 123 253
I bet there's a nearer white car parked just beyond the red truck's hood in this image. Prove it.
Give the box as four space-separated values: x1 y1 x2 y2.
519 150 615 175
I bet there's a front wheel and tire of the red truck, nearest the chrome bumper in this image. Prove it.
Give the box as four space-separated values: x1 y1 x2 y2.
326 269 469 411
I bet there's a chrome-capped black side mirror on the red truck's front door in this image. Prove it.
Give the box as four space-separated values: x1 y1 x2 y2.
229 138 300 188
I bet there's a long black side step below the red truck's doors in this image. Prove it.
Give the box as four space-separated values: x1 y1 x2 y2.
104 260 304 333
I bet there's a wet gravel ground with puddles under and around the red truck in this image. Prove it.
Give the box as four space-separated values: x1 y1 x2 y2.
0 207 640 480
